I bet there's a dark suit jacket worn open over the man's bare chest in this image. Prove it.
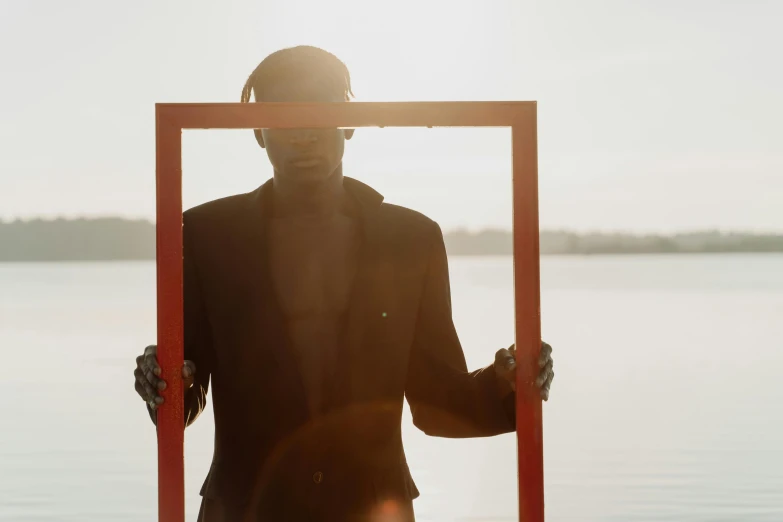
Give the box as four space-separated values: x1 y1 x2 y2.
177 178 515 520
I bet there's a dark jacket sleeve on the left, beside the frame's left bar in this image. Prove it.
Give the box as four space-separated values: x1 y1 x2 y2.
148 214 214 426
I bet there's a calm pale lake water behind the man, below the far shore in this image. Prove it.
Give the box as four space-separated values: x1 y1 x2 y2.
0 255 783 522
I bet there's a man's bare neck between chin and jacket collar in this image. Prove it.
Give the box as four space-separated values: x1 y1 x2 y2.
273 166 346 217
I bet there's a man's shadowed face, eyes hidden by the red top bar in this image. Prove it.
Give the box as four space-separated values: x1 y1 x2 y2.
256 78 352 184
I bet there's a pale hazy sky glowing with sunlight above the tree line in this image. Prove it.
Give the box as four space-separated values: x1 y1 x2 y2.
0 0 783 233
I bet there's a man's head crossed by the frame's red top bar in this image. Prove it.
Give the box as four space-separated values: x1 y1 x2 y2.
242 46 353 184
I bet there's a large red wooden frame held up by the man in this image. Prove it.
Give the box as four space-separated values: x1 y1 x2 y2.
156 102 544 522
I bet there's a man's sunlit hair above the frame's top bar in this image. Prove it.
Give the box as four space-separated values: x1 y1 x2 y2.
241 45 353 103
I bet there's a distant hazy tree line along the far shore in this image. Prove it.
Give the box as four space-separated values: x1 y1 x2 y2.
0 218 783 262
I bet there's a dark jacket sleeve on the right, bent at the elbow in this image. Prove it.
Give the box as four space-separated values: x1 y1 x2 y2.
405 221 515 438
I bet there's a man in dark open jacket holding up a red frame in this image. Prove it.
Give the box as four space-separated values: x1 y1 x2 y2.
135 46 554 522
